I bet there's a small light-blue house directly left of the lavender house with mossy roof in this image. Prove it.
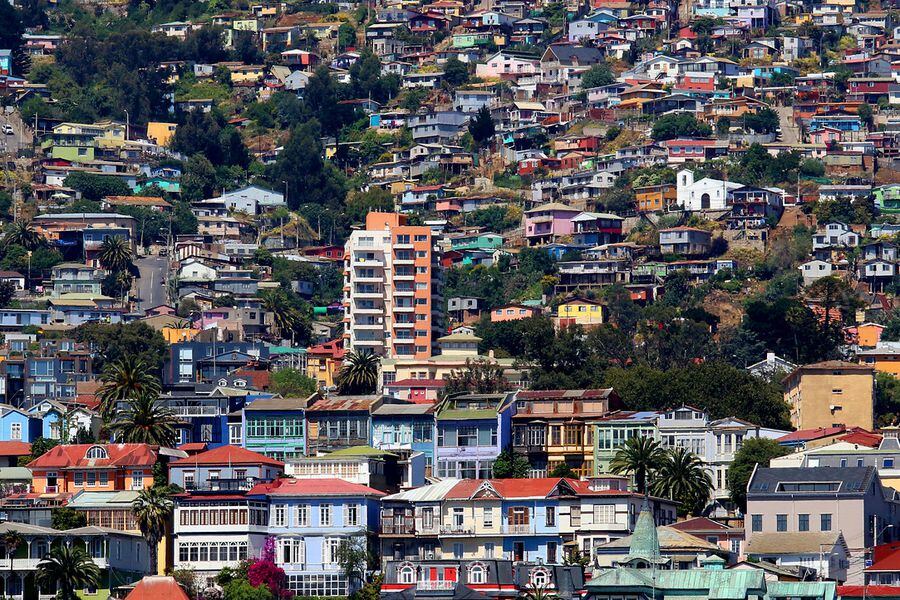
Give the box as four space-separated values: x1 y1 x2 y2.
372 402 434 476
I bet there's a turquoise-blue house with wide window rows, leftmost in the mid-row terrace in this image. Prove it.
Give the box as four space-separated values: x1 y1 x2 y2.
232 398 306 460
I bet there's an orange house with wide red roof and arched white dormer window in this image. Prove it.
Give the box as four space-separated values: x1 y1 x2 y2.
26 444 159 497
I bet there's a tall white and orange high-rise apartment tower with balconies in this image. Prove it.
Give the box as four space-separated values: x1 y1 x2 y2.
344 212 443 358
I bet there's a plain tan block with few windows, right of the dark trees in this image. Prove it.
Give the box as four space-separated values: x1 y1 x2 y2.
783 360 875 431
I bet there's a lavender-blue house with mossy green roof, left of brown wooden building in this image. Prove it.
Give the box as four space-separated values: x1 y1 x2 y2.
435 393 516 479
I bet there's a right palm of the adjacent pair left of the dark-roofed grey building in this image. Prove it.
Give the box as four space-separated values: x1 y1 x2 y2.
651 447 713 515
